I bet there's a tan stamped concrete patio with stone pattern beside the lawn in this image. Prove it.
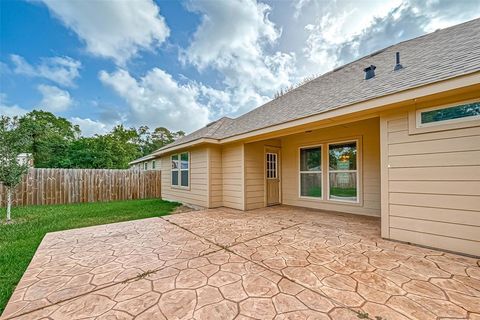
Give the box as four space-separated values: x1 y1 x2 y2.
2 206 480 320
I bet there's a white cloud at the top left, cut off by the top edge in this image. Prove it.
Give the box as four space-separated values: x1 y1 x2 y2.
43 0 170 65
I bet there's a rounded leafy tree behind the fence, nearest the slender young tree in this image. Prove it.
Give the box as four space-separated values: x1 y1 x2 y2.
18 110 80 168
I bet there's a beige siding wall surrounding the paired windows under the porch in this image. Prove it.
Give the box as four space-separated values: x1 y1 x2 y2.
281 118 381 216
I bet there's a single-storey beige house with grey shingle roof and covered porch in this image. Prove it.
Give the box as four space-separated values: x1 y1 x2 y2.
152 19 480 256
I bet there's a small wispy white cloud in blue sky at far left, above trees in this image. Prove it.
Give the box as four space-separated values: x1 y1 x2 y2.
10 54 82 87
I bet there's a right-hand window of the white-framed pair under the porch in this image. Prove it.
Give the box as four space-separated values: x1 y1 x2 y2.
328 141 358 202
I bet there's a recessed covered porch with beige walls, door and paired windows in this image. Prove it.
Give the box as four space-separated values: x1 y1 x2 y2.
244 117 381 217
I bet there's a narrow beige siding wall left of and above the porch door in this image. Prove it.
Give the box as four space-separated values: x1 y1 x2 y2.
245 139 281 210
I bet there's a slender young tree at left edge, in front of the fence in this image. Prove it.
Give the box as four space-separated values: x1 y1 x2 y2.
0 116 28 223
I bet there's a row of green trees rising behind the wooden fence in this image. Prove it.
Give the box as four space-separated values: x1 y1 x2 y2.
0 110 185 169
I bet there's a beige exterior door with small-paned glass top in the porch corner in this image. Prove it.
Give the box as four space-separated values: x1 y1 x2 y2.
265 149 280 206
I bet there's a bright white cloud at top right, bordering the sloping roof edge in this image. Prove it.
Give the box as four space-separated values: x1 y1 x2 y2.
297 0 480 73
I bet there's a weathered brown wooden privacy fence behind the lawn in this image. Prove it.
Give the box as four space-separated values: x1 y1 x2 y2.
0 169 161 207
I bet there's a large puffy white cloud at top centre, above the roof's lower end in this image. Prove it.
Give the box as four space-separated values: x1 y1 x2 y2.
180 0 295 115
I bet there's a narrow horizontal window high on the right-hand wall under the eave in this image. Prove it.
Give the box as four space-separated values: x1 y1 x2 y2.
417 102 480 127
